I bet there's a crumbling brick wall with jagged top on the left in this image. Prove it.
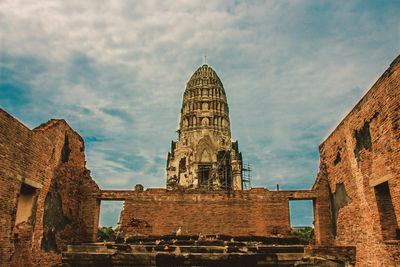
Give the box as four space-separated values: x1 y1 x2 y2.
0 109 99 266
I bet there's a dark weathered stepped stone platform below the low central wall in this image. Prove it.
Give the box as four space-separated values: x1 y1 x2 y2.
63 236 304 266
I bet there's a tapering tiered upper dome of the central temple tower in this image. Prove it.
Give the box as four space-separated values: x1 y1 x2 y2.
179 63 231 137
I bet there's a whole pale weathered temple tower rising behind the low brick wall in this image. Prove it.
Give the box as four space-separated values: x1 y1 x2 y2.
167 62 242 190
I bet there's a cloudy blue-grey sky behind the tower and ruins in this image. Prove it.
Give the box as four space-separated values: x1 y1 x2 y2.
0 0 400 228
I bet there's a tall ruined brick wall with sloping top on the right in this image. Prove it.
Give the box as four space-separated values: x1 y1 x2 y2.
313 56 400 266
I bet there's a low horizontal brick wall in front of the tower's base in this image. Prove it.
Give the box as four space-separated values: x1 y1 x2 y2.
114 188 312 238
